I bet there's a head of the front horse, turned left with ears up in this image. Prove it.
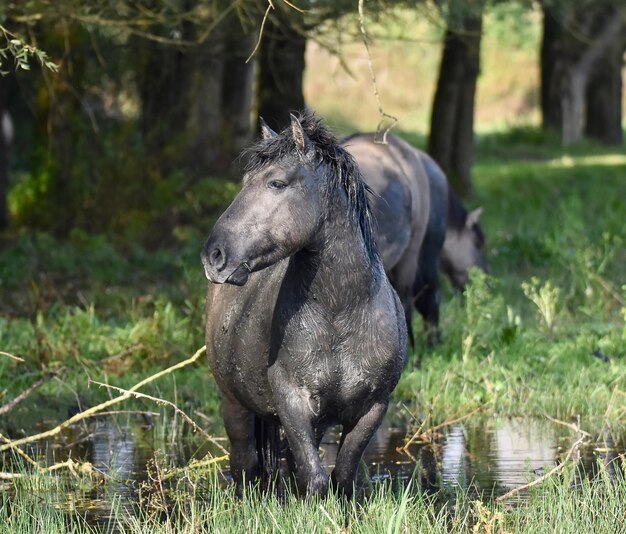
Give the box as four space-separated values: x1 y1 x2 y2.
202 115 325 285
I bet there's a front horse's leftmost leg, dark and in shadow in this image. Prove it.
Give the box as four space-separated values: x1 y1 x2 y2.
222 396 259 497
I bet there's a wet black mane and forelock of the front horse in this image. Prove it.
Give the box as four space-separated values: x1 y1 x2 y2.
246 111 376 257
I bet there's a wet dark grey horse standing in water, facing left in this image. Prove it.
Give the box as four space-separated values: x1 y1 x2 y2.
202 115 406 496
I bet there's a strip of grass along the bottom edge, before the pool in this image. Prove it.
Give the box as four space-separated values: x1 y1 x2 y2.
0 458 626 534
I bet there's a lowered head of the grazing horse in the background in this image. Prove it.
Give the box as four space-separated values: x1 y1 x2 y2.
441 208 487 291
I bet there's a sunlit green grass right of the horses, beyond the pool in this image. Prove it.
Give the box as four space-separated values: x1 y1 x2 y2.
396 138 626 429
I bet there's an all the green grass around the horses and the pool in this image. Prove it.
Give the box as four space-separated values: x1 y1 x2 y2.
0 129 626 532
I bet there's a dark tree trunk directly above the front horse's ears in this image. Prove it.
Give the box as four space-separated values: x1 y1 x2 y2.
258 6 306 131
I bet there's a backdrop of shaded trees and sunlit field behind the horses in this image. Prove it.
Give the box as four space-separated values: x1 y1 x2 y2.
0 0 626 240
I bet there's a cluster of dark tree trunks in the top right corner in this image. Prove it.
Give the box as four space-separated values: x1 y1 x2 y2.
541 0 626 145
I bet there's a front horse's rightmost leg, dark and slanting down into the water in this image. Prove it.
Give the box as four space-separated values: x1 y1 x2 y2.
332 402 387 498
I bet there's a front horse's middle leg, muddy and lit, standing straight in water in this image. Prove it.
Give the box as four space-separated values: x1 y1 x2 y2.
270 366 328 496
